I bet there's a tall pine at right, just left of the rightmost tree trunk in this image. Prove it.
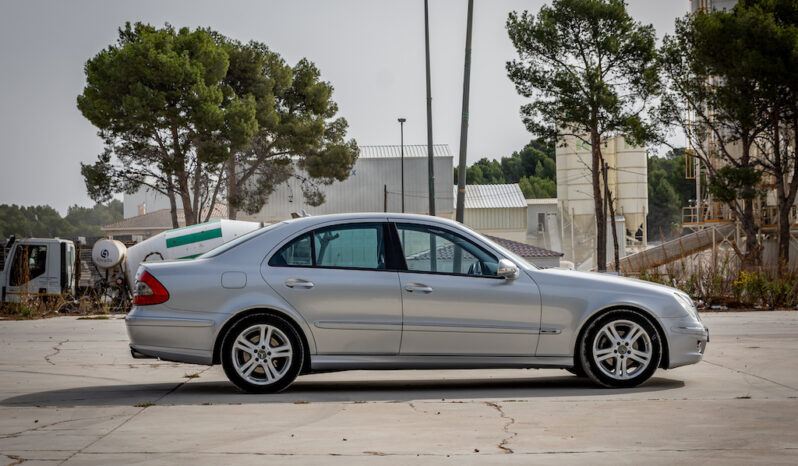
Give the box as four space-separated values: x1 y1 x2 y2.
660 4 794 267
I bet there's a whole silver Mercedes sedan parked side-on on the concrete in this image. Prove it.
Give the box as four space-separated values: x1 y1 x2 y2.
126 214 709 393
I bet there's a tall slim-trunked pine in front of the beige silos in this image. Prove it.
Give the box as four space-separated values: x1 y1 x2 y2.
507 0 658 270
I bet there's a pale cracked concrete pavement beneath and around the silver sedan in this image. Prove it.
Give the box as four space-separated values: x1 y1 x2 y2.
0 312 798 465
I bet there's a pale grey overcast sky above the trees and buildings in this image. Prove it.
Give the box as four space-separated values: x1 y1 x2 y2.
0 0 689 213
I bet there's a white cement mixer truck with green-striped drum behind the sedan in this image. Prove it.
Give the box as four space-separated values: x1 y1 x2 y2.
0 220 263 308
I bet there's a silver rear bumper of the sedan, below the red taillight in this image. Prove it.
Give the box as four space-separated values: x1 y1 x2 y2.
125 307 215 365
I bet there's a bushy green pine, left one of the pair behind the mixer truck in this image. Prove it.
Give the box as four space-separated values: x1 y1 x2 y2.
77 23 250 227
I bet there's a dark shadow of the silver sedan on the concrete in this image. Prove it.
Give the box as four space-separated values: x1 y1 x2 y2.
0 375 684 407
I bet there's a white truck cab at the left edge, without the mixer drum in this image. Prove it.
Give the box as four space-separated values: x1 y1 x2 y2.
0 238 75 302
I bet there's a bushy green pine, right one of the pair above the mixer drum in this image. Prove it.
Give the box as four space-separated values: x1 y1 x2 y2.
217 38 359 219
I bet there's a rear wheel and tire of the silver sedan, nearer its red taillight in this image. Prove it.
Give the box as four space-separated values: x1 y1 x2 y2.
221 314 305 393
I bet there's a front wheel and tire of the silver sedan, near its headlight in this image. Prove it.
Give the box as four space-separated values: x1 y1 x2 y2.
579 310 662 388
